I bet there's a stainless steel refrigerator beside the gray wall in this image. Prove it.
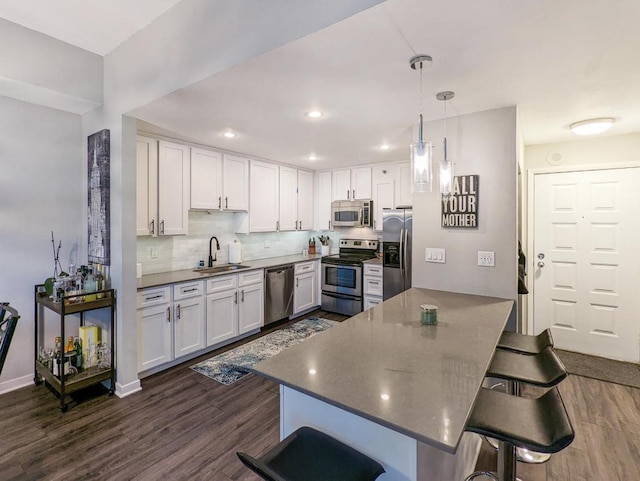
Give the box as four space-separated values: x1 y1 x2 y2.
382 208 413 300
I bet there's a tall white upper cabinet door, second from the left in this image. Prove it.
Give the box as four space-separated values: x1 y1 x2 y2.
158 141 191 235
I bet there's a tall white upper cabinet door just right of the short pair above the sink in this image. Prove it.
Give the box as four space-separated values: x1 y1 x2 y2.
249 160 279 232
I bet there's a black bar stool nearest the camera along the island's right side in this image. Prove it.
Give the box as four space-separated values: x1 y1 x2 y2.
465 387 575 481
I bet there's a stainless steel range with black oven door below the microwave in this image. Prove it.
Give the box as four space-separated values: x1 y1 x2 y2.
321 239 378 316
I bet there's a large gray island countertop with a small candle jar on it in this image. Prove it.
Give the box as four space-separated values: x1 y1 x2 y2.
253 288 514 453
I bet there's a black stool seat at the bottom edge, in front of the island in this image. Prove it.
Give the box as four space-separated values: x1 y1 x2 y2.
236 426 385 481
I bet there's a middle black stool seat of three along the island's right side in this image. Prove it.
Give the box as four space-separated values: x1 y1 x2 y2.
487 347 567 387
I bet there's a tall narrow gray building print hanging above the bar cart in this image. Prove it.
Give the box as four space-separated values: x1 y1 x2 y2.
87 129 111 265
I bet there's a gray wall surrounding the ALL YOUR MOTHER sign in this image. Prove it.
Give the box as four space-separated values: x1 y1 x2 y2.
412 107 517 299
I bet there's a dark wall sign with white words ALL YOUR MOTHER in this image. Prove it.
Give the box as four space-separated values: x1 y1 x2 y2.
441 175 480 228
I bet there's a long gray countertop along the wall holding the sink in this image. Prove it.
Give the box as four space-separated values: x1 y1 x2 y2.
136 254 322 290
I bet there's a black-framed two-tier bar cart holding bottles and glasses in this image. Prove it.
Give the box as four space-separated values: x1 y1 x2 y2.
34 284 116 412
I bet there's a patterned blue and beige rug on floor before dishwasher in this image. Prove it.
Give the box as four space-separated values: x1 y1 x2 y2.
191 317 338 386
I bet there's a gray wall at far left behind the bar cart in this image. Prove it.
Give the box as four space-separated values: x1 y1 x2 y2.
0 97 86 392
